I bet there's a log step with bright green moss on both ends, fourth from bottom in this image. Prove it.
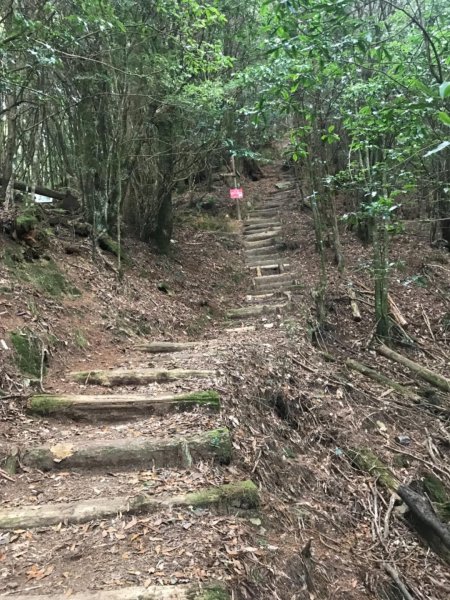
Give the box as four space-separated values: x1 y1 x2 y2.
27 390 220 419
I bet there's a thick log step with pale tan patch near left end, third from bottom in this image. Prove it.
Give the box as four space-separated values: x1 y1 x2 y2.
14 428 232 471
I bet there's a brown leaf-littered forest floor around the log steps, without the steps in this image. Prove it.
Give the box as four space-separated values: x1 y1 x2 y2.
0 167 450 600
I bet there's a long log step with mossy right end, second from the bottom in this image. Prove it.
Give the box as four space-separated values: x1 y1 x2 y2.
0 481 259 529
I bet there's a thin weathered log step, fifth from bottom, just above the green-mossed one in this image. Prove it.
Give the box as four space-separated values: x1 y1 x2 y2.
69 369 215 387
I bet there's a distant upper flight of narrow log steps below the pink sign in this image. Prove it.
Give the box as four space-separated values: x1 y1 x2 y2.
227 175 296 321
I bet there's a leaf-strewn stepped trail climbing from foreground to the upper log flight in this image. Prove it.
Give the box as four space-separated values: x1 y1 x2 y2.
0 165 295 600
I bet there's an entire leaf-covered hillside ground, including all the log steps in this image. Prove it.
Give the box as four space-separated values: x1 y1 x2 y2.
0 162 450 600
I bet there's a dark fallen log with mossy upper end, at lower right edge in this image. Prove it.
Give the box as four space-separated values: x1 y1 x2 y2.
347 448 450 563
